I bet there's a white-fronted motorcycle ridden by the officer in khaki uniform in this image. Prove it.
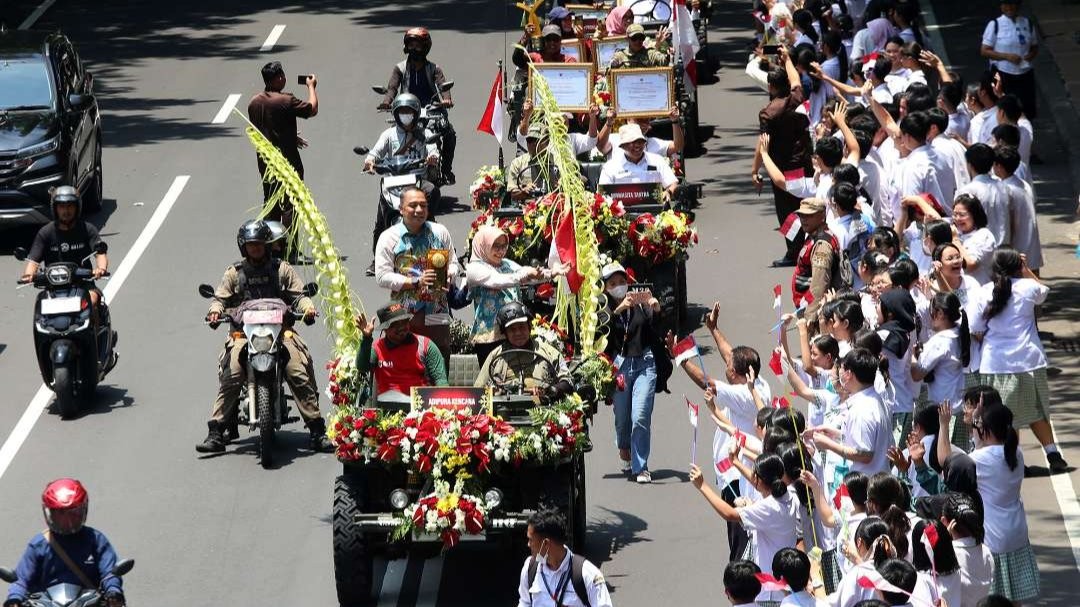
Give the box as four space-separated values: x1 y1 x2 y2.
199 283 319 468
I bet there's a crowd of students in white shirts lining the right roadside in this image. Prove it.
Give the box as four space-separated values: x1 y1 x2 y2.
680 0 1067 607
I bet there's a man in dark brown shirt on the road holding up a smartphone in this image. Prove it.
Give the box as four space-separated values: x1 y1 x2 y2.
247 62 319 243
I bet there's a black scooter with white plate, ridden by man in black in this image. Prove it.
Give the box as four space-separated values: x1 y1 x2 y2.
15 243 118 418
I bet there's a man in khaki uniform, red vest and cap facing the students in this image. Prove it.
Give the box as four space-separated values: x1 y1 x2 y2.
792 198 851 320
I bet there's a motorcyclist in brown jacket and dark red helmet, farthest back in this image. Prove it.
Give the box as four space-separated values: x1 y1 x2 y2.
379 27 458 186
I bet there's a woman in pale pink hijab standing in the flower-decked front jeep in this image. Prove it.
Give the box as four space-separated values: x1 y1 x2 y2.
465 225 550 365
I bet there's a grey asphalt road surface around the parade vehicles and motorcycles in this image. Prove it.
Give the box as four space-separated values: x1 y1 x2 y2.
0 0 1075 607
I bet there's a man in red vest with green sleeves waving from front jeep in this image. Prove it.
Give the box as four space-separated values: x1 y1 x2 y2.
356 301 447 394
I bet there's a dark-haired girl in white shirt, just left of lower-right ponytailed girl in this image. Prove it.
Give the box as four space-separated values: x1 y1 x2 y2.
939 494 994 607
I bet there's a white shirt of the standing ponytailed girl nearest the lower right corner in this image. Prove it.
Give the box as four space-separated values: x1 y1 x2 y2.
971 445 1030 555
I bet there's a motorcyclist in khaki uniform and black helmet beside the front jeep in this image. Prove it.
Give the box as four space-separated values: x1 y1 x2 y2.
195 219 334 454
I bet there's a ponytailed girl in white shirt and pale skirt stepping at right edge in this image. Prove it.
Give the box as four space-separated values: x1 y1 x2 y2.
972 246 1068 472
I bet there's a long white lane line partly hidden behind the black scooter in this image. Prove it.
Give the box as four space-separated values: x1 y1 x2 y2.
0 175 190 478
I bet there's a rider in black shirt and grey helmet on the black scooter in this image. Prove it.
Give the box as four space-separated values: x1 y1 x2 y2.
19 186 117 340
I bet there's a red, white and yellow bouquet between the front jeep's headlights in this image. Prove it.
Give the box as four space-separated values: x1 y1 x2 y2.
393 481 487 550
